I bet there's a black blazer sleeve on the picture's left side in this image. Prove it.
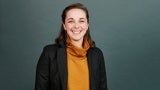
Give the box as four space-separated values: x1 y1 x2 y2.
34 47 50 90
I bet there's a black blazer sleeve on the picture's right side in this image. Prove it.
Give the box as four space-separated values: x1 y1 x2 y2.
99 50 108 90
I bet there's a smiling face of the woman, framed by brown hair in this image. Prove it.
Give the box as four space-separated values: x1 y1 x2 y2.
63 9 89 41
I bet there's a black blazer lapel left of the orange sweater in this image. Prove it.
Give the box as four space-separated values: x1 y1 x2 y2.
57 48 67 90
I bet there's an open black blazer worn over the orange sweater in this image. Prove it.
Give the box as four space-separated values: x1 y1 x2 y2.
35 42 107 90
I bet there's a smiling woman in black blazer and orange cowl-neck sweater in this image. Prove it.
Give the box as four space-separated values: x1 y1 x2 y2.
35 3 107 90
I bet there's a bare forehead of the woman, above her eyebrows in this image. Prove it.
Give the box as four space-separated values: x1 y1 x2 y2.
66 9 86 18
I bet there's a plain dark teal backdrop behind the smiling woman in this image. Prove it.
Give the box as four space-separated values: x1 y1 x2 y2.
0 0 160 90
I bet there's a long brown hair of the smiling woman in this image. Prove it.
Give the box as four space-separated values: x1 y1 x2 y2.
55 3 95 47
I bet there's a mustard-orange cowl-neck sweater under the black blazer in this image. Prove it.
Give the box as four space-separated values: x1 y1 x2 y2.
67 38 89 90
